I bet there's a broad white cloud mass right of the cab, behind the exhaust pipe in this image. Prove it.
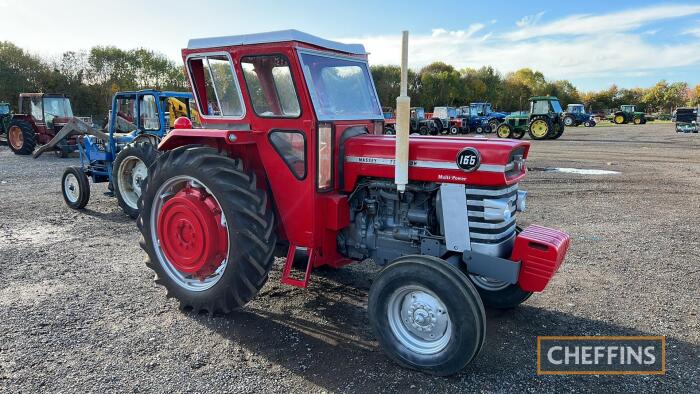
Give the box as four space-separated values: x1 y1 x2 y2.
342 6 700 82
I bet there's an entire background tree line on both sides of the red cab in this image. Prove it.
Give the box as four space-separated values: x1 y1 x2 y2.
0 42 700 117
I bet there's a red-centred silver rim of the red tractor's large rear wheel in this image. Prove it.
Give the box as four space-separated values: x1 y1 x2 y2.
157 185 228 279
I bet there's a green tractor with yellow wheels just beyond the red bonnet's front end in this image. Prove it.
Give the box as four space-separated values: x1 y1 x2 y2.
496 96 564 140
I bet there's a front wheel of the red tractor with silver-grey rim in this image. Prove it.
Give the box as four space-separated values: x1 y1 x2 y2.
368 255 486 376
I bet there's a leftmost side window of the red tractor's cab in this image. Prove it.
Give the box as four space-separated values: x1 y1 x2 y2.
188 54 245 118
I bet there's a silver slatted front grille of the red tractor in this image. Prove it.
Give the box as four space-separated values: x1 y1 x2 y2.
466 184 518 255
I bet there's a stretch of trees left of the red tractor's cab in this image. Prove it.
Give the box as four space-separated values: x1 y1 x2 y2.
0 42 188 121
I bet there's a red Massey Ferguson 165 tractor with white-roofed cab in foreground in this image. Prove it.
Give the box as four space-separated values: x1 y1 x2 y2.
137 30 569 375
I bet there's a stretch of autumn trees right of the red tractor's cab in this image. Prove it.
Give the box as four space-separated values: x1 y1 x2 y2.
371 62 700 113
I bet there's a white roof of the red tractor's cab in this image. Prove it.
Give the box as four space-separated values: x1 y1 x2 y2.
187 29 367 55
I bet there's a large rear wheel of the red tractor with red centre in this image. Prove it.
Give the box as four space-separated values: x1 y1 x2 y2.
137 146 277 314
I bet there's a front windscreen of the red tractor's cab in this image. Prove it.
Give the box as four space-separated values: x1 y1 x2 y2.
300 52 383 120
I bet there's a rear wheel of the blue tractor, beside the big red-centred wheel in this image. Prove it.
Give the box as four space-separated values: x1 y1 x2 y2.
112 141 158 219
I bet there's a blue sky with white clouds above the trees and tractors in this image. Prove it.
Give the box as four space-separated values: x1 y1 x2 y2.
0 0 700 91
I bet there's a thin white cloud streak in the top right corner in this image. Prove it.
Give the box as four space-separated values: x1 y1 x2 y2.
504 4 700 41
